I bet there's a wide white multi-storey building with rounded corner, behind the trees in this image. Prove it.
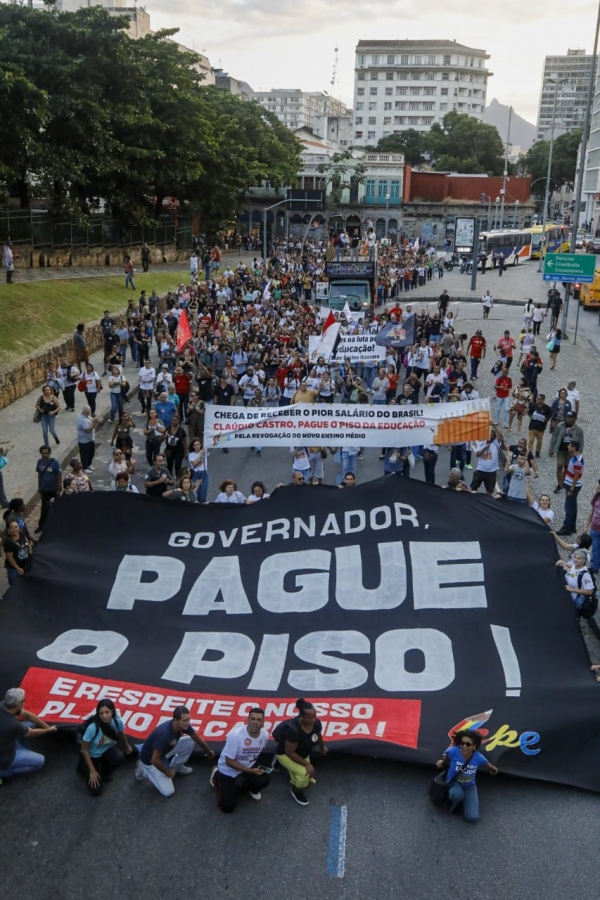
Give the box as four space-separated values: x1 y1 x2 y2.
354 41 492 146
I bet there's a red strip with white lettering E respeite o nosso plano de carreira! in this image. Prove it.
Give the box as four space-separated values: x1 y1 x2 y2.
21 667 421 748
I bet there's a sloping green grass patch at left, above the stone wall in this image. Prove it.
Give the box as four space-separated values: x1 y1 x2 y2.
0 269 189 368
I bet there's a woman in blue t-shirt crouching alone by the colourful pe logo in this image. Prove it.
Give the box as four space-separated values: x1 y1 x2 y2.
436 731 498 822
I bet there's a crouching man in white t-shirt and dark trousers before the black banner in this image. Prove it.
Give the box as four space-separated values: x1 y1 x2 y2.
210 706 271 812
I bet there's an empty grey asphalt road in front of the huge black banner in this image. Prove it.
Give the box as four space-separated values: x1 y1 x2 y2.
0 734 600 900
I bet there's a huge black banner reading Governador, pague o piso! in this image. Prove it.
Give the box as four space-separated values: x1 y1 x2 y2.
0 478 600 790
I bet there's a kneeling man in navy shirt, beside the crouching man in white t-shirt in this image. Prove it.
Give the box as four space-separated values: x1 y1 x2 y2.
135 706 215 797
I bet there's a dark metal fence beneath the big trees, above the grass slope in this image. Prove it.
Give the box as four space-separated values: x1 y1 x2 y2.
0 209 192 250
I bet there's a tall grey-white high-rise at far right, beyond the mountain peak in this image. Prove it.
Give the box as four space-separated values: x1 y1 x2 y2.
537 50 593 141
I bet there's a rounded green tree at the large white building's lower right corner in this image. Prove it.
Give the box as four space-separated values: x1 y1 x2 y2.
424 112 504 175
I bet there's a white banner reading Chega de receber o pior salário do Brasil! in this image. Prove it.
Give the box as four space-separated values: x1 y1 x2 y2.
204 399 490 449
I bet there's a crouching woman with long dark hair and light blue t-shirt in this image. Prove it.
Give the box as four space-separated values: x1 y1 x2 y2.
77 699 137 797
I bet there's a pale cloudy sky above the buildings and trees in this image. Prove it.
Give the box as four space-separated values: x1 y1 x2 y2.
150 0 596 124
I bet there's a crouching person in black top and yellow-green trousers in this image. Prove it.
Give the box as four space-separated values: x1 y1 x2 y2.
273 697 328 806
